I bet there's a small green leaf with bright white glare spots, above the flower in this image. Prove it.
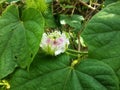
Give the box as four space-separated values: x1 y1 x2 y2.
60 15 84 31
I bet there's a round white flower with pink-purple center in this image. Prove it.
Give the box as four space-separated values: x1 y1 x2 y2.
40 31 69 56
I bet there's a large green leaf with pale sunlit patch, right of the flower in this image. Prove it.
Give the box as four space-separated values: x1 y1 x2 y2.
82 2 120 85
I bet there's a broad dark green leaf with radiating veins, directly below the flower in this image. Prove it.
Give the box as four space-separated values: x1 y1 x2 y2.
9 55 119 90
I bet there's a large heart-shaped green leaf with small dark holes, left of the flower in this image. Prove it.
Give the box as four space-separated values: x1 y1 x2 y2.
0 5 44 79
